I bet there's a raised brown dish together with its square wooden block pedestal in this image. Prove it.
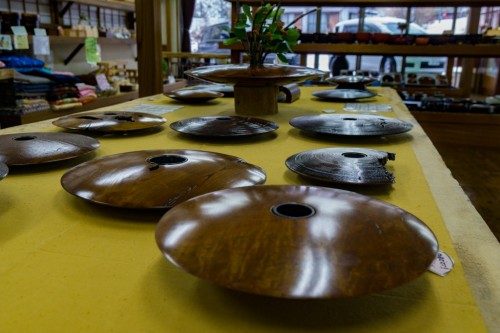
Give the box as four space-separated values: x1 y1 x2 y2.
184 64 325 115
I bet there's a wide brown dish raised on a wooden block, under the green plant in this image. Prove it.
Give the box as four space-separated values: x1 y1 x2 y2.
184 64 325 85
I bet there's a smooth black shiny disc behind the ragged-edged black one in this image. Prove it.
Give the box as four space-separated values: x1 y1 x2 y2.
290 114 413 136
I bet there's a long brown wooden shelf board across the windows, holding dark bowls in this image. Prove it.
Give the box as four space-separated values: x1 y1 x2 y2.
219 43 500 58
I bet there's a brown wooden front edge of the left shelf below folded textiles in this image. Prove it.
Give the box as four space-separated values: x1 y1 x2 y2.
0 91 139 128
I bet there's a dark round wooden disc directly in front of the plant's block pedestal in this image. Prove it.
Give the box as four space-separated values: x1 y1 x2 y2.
170 116 279 138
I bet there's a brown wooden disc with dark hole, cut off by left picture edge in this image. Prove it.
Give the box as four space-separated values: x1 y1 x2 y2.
0 132 99 166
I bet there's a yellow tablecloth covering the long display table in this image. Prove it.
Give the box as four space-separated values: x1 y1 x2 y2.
0 88 492 332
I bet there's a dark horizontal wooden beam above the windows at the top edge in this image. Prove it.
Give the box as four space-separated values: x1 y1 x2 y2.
227 0 500 7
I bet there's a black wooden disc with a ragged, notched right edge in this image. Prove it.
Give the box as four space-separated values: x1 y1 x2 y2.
285 148 395 185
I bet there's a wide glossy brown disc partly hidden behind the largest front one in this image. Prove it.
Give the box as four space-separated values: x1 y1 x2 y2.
61 150 266 209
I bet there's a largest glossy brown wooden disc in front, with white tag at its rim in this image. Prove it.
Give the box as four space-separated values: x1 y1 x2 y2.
156 186 438 298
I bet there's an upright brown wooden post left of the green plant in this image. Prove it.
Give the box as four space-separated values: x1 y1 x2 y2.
135 0 163 97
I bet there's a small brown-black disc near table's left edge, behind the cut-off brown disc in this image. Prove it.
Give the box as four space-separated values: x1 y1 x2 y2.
52 111 166 133
